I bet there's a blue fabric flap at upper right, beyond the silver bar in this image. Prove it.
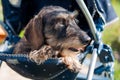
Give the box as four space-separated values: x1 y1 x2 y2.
86 0 117 23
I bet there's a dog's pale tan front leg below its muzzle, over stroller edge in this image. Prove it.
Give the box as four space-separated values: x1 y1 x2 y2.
60 49 82 72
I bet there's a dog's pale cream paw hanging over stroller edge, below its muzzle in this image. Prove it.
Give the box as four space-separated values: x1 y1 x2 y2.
62 57 82 72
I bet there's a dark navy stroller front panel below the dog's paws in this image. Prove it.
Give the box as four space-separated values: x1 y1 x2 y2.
8 59 78 80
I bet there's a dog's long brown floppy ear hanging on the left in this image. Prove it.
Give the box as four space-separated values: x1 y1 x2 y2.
24 16 44 49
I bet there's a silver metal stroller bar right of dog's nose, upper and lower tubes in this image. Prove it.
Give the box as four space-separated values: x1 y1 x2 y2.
76 0 100 80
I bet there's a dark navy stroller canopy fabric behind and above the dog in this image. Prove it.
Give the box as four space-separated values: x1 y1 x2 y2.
2 0 117 34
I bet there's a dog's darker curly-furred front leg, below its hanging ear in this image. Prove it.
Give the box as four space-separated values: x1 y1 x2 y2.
29 45 57 64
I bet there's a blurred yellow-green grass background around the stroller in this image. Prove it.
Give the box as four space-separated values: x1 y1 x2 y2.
0 0 120 80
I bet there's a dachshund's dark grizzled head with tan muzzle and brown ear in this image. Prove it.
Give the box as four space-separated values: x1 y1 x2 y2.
25 6 90 49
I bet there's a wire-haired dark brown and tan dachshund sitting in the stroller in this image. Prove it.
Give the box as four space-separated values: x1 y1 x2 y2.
14 6 91 71
